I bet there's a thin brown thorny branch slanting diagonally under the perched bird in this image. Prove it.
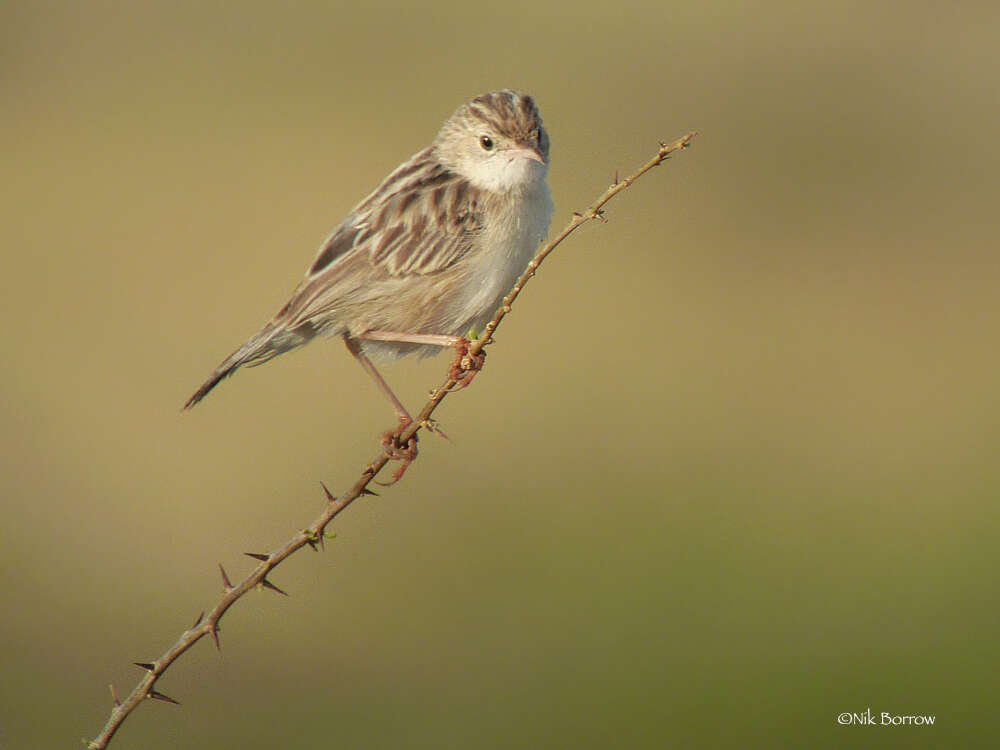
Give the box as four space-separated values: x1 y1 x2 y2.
87 133 696 750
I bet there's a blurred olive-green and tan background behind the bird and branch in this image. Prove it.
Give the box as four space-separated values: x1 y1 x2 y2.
0 0 1000 750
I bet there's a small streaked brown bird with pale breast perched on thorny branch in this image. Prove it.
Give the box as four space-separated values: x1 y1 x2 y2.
184 89 553 425
